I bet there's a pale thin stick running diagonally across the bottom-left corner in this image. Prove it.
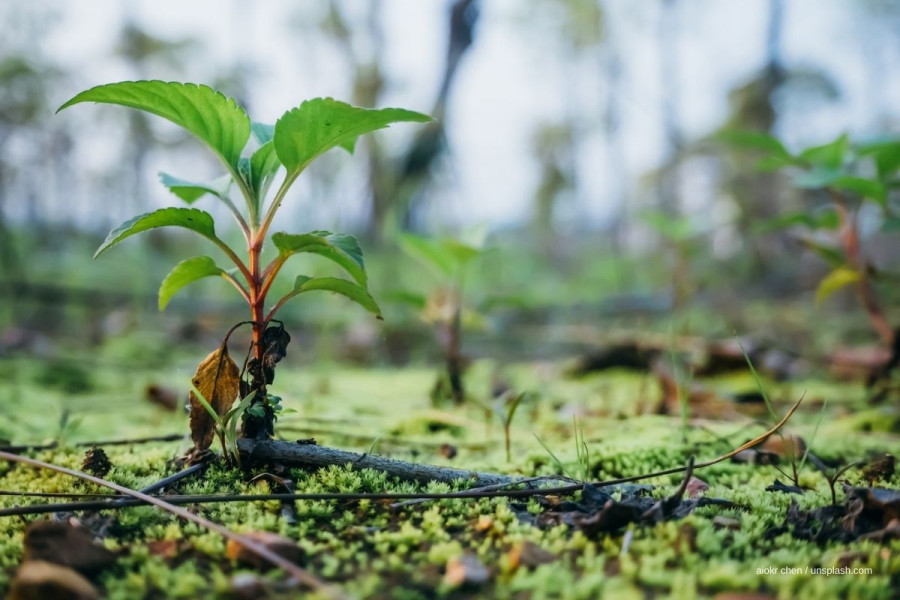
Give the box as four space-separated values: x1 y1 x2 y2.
0 451 344 598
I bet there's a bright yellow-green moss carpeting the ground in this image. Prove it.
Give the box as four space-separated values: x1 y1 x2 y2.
0 358 900 599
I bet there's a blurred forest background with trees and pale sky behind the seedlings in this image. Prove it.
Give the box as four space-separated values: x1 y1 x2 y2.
0 0 900 372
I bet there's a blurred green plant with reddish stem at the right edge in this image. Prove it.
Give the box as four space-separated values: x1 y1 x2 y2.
720 131 900 346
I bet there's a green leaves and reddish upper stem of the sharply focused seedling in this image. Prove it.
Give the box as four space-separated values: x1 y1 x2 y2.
59 81 431 318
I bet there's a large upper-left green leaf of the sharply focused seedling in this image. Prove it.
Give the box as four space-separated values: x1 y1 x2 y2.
56 81 250 171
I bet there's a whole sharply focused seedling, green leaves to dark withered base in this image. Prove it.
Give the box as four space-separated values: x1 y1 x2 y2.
59 81 431 452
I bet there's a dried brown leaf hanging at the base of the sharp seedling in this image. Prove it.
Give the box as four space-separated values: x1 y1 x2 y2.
191 346 240 452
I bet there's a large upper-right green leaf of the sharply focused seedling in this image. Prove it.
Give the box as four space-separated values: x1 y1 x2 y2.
274 98 432 180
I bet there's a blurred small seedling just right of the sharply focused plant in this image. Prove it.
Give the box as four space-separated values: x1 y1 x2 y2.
399 233 486 404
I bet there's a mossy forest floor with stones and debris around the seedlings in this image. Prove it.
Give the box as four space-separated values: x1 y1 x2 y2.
0 342 900 600
